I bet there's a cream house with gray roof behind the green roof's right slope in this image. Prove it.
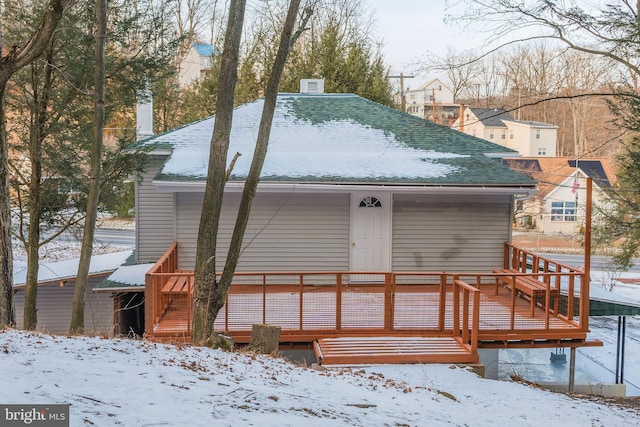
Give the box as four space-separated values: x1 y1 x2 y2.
451 107 558 157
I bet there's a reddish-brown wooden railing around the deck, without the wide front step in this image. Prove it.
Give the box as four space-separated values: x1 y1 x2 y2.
146 244 588 352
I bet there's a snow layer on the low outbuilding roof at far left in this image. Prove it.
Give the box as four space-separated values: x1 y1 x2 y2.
13 250 132 286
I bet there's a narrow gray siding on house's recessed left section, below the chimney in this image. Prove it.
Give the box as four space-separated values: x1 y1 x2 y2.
136 156 175 262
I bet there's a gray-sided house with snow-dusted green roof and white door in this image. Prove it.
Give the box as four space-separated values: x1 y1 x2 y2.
103 89 535 338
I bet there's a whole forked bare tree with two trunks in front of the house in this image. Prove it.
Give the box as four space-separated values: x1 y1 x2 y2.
192 0 312 345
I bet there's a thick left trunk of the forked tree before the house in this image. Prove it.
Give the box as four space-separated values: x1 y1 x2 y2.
191 0 246 345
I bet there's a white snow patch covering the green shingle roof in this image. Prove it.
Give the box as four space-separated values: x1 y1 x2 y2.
157 96 462 179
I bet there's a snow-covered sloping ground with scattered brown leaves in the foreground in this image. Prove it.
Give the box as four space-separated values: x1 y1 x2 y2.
0 330 640 427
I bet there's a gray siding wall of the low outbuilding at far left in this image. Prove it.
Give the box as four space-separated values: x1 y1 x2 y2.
14 274 113 335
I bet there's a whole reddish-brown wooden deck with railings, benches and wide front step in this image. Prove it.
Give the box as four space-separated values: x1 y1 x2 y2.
146 245 588 363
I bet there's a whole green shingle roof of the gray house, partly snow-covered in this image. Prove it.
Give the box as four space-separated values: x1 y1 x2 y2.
144 94 529 185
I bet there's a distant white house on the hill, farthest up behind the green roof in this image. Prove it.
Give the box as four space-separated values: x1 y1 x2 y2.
405 79 460 126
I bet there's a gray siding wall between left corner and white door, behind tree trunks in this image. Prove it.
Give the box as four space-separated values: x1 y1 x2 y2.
177 193 349 271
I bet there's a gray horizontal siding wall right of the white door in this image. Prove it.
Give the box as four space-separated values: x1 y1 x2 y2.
392 195 512 272
